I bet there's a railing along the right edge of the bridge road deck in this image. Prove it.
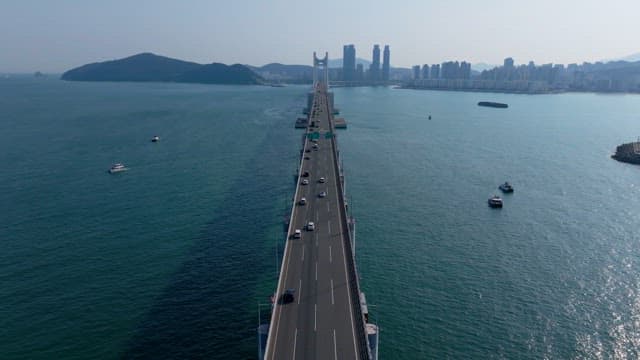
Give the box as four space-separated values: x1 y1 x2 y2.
327 95 371 360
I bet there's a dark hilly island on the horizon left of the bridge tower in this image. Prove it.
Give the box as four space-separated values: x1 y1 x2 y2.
62 53 264 85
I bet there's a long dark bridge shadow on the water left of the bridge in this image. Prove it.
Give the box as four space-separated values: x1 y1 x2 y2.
121 123 295 359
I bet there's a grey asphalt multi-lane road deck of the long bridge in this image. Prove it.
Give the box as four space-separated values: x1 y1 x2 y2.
265 90 366 359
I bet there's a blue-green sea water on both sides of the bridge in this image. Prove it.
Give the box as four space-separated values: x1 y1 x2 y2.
0 76 640 359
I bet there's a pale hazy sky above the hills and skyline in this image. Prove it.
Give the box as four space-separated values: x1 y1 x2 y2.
0 0 640 72
